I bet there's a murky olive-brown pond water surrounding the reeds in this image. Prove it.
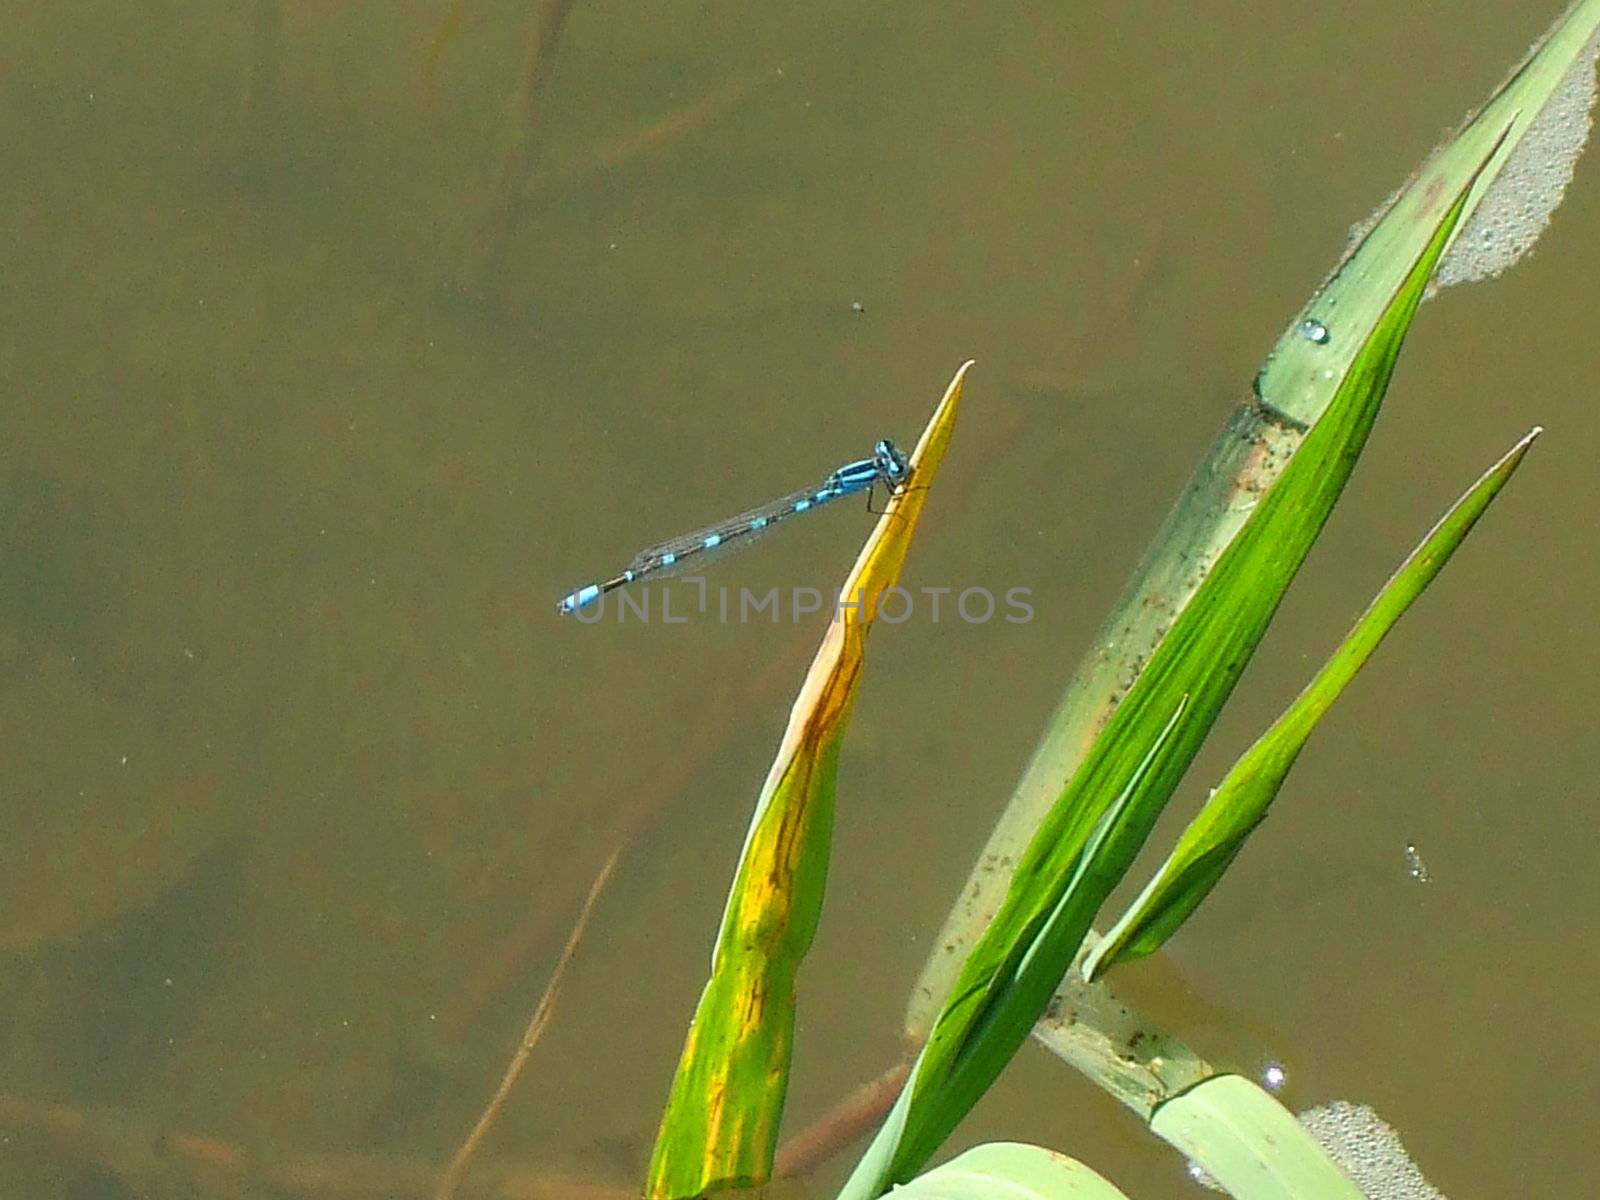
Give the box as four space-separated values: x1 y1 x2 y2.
0 0 1600 1200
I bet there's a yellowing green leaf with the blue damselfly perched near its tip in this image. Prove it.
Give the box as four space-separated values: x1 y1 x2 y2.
645 363 971 1200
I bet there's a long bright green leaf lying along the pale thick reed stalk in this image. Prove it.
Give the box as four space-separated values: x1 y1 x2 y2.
845 147 1494 1200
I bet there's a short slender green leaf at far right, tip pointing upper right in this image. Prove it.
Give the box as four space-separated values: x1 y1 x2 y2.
1083 429 1539 979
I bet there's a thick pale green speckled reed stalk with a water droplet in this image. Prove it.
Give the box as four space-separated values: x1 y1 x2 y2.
906 0 1600 1042
